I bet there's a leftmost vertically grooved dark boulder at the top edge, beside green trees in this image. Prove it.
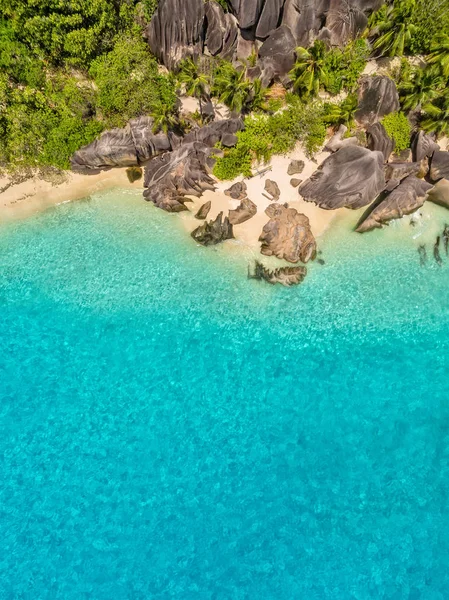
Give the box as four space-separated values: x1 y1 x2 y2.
145 0 205 69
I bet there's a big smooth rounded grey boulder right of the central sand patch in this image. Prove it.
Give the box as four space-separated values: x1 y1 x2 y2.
299 146 385 210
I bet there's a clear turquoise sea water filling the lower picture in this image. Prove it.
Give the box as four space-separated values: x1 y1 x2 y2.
0 191 449 600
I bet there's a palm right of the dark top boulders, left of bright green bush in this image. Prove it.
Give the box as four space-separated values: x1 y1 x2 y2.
289 40 328 98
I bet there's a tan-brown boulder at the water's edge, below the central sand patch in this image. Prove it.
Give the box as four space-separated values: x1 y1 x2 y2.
259 204 316 263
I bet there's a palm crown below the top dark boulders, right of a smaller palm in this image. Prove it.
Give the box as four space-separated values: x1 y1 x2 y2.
212 62 251 112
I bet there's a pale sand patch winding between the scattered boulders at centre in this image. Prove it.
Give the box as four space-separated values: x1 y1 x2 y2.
181 144 358 255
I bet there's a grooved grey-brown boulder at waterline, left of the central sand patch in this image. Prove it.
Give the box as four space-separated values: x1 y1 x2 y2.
143 142 215 212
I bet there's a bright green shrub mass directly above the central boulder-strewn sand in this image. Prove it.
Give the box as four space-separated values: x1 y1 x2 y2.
214 96 326 179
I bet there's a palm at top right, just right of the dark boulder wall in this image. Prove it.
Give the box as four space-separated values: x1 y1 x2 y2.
369 0 417 56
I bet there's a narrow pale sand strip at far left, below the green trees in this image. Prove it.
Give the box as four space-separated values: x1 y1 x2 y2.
0 168 142 223
